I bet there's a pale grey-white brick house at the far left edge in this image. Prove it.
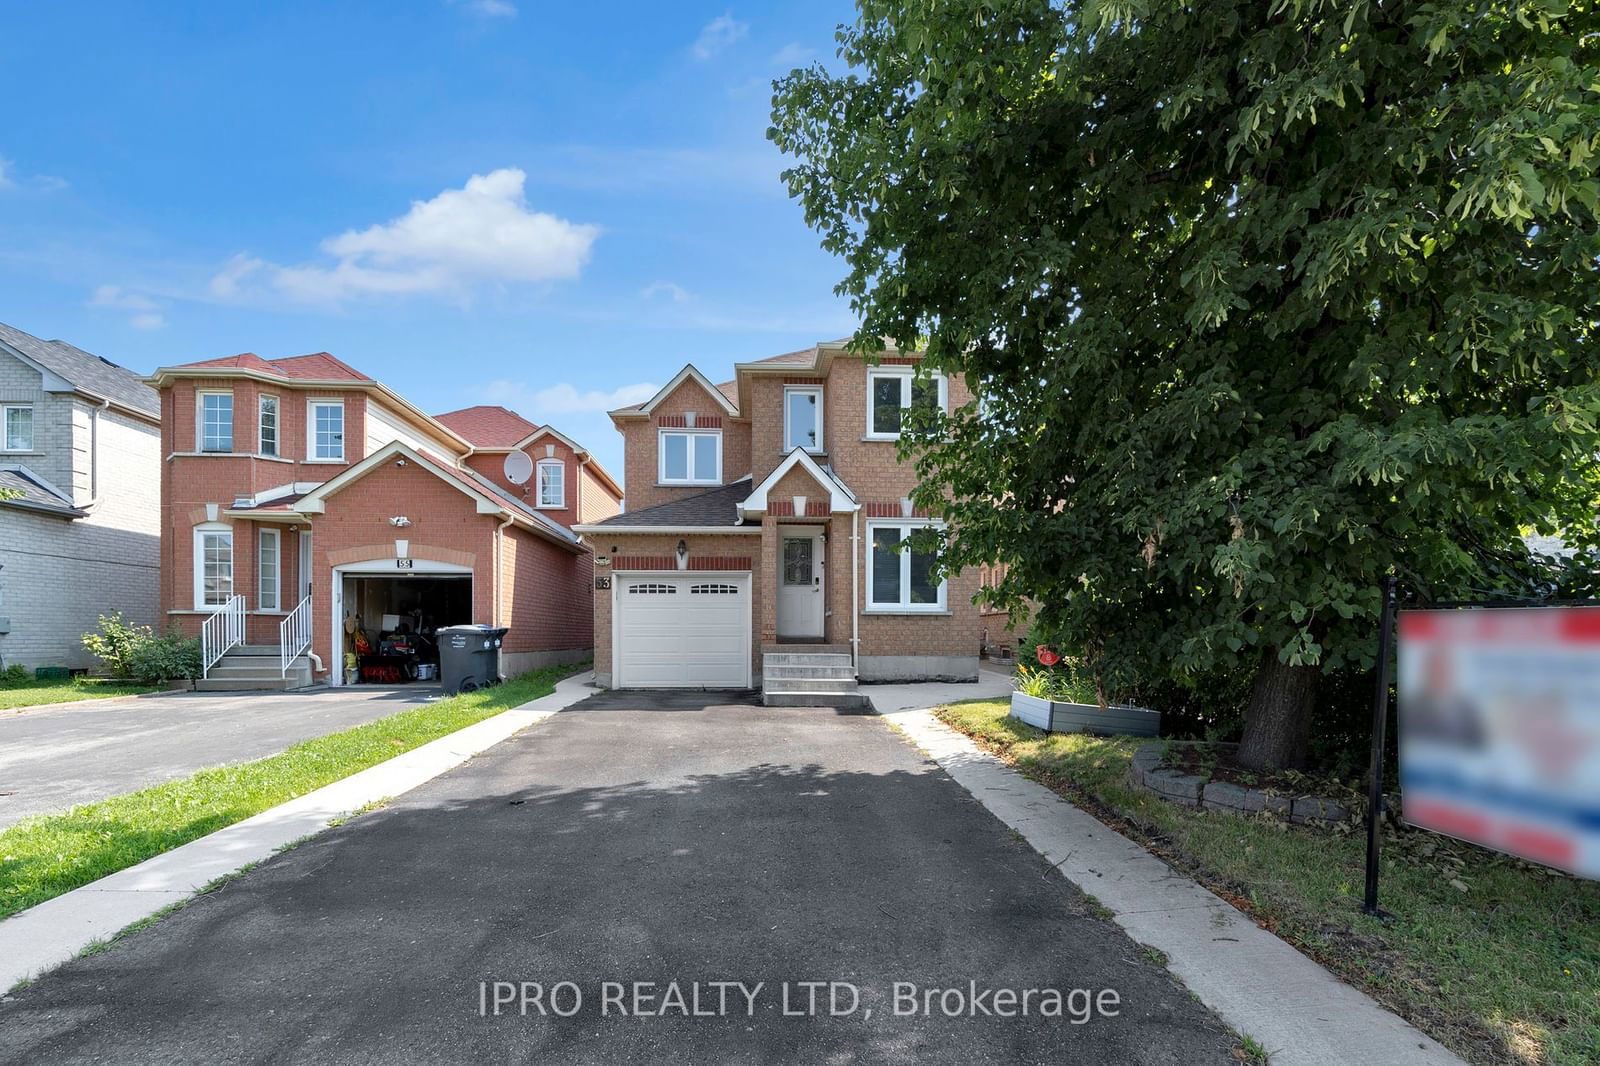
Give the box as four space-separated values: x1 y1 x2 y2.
0 316 162 667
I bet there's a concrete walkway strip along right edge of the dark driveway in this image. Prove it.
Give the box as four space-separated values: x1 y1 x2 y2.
885 693 1462 1066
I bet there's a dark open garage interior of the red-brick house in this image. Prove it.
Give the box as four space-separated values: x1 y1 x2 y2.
342 575 474 685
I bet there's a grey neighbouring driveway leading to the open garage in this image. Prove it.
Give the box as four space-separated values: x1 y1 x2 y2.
0 685 440 829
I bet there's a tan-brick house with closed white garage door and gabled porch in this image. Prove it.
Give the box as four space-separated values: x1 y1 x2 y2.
576 334 982 701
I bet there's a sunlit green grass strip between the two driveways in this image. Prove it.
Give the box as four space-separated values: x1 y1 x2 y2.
0 664 587 917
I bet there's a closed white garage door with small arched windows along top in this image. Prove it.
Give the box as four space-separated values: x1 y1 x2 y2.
613 575 750 688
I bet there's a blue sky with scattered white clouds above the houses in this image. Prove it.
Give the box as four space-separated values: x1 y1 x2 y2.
0 0 851 477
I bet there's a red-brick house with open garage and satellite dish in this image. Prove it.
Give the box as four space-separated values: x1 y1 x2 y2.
149 354 622 687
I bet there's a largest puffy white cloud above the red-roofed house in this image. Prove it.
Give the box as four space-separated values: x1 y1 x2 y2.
211 168 600 304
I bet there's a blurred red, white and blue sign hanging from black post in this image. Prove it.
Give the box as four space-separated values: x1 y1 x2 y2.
1397 607 1600 877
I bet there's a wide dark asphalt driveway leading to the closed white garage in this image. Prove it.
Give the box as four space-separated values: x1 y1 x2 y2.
0 693 1234 1066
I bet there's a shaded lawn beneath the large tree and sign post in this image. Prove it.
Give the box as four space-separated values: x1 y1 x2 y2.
938 701 1600 1066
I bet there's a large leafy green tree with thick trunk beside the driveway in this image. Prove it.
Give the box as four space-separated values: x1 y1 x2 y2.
771 0 1600 767
